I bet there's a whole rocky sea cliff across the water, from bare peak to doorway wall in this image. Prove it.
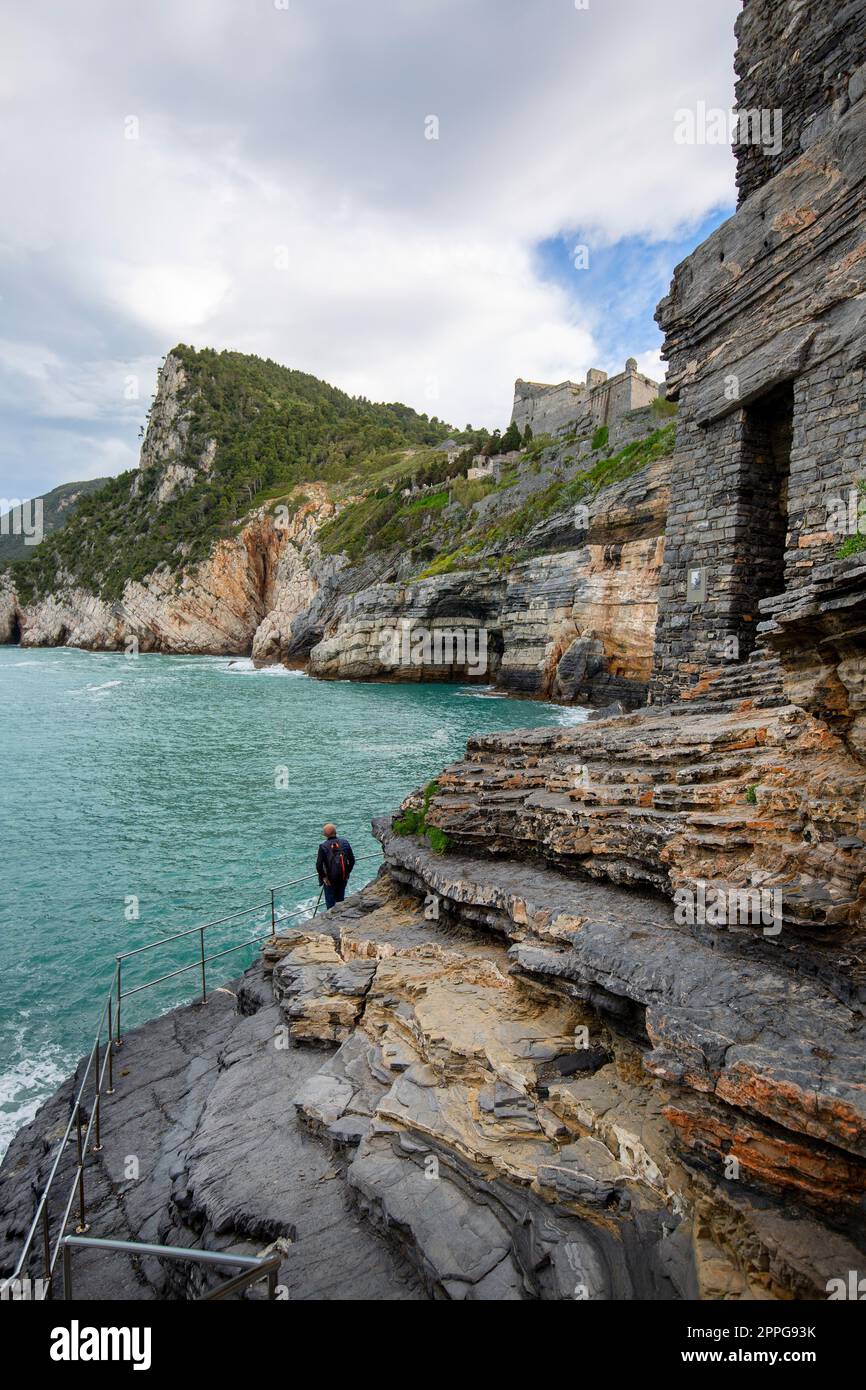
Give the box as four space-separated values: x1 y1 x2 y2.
0 349 673 705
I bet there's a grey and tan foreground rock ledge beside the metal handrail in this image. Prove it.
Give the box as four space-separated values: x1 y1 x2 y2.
0 856 866 1301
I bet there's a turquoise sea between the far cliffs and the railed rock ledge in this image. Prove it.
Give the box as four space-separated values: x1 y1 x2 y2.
0 646 584 1152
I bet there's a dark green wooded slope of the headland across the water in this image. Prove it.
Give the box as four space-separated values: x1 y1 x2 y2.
6 345 461 599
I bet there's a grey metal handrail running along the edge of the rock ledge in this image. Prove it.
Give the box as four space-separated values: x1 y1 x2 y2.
0 853 379 1298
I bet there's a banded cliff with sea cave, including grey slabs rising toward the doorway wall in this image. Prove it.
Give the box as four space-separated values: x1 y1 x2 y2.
304 459 669 705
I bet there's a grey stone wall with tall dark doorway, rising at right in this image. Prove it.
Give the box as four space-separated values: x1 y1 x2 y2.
653 46 866 699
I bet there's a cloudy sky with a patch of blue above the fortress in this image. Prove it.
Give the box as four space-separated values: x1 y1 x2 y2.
0 0 740 499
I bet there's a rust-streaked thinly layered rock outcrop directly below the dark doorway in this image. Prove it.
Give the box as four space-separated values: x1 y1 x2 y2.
414 699 866 934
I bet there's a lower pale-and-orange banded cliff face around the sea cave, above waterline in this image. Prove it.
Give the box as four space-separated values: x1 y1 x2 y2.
310 538 663 703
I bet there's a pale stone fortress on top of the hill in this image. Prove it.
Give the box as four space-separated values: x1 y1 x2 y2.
512 357 662 435
